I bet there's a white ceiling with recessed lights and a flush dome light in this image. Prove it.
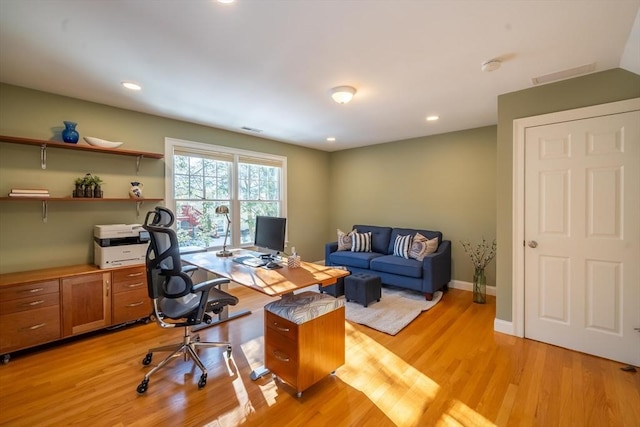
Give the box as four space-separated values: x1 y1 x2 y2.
0 0 640 151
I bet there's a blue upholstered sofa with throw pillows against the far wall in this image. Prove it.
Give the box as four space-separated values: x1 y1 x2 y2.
324 225 451 300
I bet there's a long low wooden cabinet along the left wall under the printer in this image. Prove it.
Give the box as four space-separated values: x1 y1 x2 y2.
0 265 151 362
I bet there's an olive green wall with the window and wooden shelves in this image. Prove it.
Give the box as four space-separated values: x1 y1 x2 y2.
0 85 330 273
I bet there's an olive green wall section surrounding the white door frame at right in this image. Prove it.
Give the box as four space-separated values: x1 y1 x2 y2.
496 68 640 321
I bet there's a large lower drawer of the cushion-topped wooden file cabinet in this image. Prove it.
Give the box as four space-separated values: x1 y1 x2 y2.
264 329 298 386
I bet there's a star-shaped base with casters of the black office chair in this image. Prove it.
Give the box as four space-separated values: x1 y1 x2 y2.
136 327 231 394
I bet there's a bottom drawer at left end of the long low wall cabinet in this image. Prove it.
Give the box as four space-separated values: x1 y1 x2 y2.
0 305 60 353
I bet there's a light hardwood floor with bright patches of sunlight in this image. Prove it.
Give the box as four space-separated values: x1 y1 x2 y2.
0 287 640 427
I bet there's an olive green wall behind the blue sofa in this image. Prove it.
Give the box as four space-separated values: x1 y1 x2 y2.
329 126 496 285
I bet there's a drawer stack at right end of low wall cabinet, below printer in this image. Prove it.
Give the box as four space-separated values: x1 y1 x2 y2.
111 265 152 324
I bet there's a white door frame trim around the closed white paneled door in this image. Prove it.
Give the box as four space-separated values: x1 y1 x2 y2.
511 98 640 337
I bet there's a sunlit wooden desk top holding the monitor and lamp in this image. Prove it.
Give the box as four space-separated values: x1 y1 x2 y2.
181 251 349 297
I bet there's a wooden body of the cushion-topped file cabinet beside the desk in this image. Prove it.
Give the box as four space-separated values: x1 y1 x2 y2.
264 306 345 395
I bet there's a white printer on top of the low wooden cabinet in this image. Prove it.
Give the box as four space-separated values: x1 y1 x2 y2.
93 224 149 268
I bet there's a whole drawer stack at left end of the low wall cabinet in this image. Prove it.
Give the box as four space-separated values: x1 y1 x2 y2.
0 279 61 354
